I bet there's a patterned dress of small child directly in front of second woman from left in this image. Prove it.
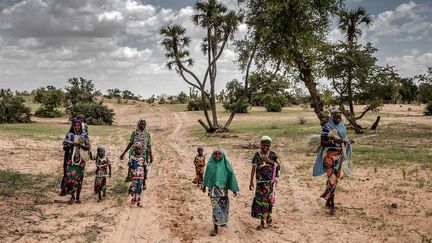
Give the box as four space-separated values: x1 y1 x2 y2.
128 155 146 203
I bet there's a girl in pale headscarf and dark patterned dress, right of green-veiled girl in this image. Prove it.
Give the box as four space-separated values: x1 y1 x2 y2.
249 136 280 230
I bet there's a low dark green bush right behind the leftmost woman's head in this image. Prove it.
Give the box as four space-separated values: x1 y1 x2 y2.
69 102 114 125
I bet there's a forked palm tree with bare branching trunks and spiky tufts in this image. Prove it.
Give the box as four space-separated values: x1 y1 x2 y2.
160 0 241 133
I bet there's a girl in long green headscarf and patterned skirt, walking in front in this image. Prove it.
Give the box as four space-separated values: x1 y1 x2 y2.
202 148 239 236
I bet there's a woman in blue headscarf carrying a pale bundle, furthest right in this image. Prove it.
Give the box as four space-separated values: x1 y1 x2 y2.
313 108 354 214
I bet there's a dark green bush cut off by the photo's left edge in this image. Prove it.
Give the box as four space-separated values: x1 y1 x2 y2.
0 89 31 123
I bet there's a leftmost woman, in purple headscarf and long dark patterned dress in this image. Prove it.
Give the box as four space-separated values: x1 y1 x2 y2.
60 119 90 203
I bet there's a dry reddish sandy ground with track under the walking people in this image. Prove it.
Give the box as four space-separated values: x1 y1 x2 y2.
0 104 432 242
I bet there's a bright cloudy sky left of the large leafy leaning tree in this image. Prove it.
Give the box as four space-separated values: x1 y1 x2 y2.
0 0 243 97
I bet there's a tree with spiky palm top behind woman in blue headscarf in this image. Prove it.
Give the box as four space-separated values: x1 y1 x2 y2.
325 7 400 133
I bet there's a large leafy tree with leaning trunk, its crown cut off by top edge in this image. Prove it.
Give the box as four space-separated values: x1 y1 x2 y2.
240 0 341 124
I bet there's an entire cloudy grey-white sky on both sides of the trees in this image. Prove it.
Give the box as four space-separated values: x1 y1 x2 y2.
0 0 432 97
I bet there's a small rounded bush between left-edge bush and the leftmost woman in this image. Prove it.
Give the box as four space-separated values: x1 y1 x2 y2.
33 86 64 117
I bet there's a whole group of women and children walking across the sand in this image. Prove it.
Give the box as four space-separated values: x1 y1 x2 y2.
60 109 353 236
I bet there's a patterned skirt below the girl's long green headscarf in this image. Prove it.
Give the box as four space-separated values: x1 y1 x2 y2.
209 187 229 225
